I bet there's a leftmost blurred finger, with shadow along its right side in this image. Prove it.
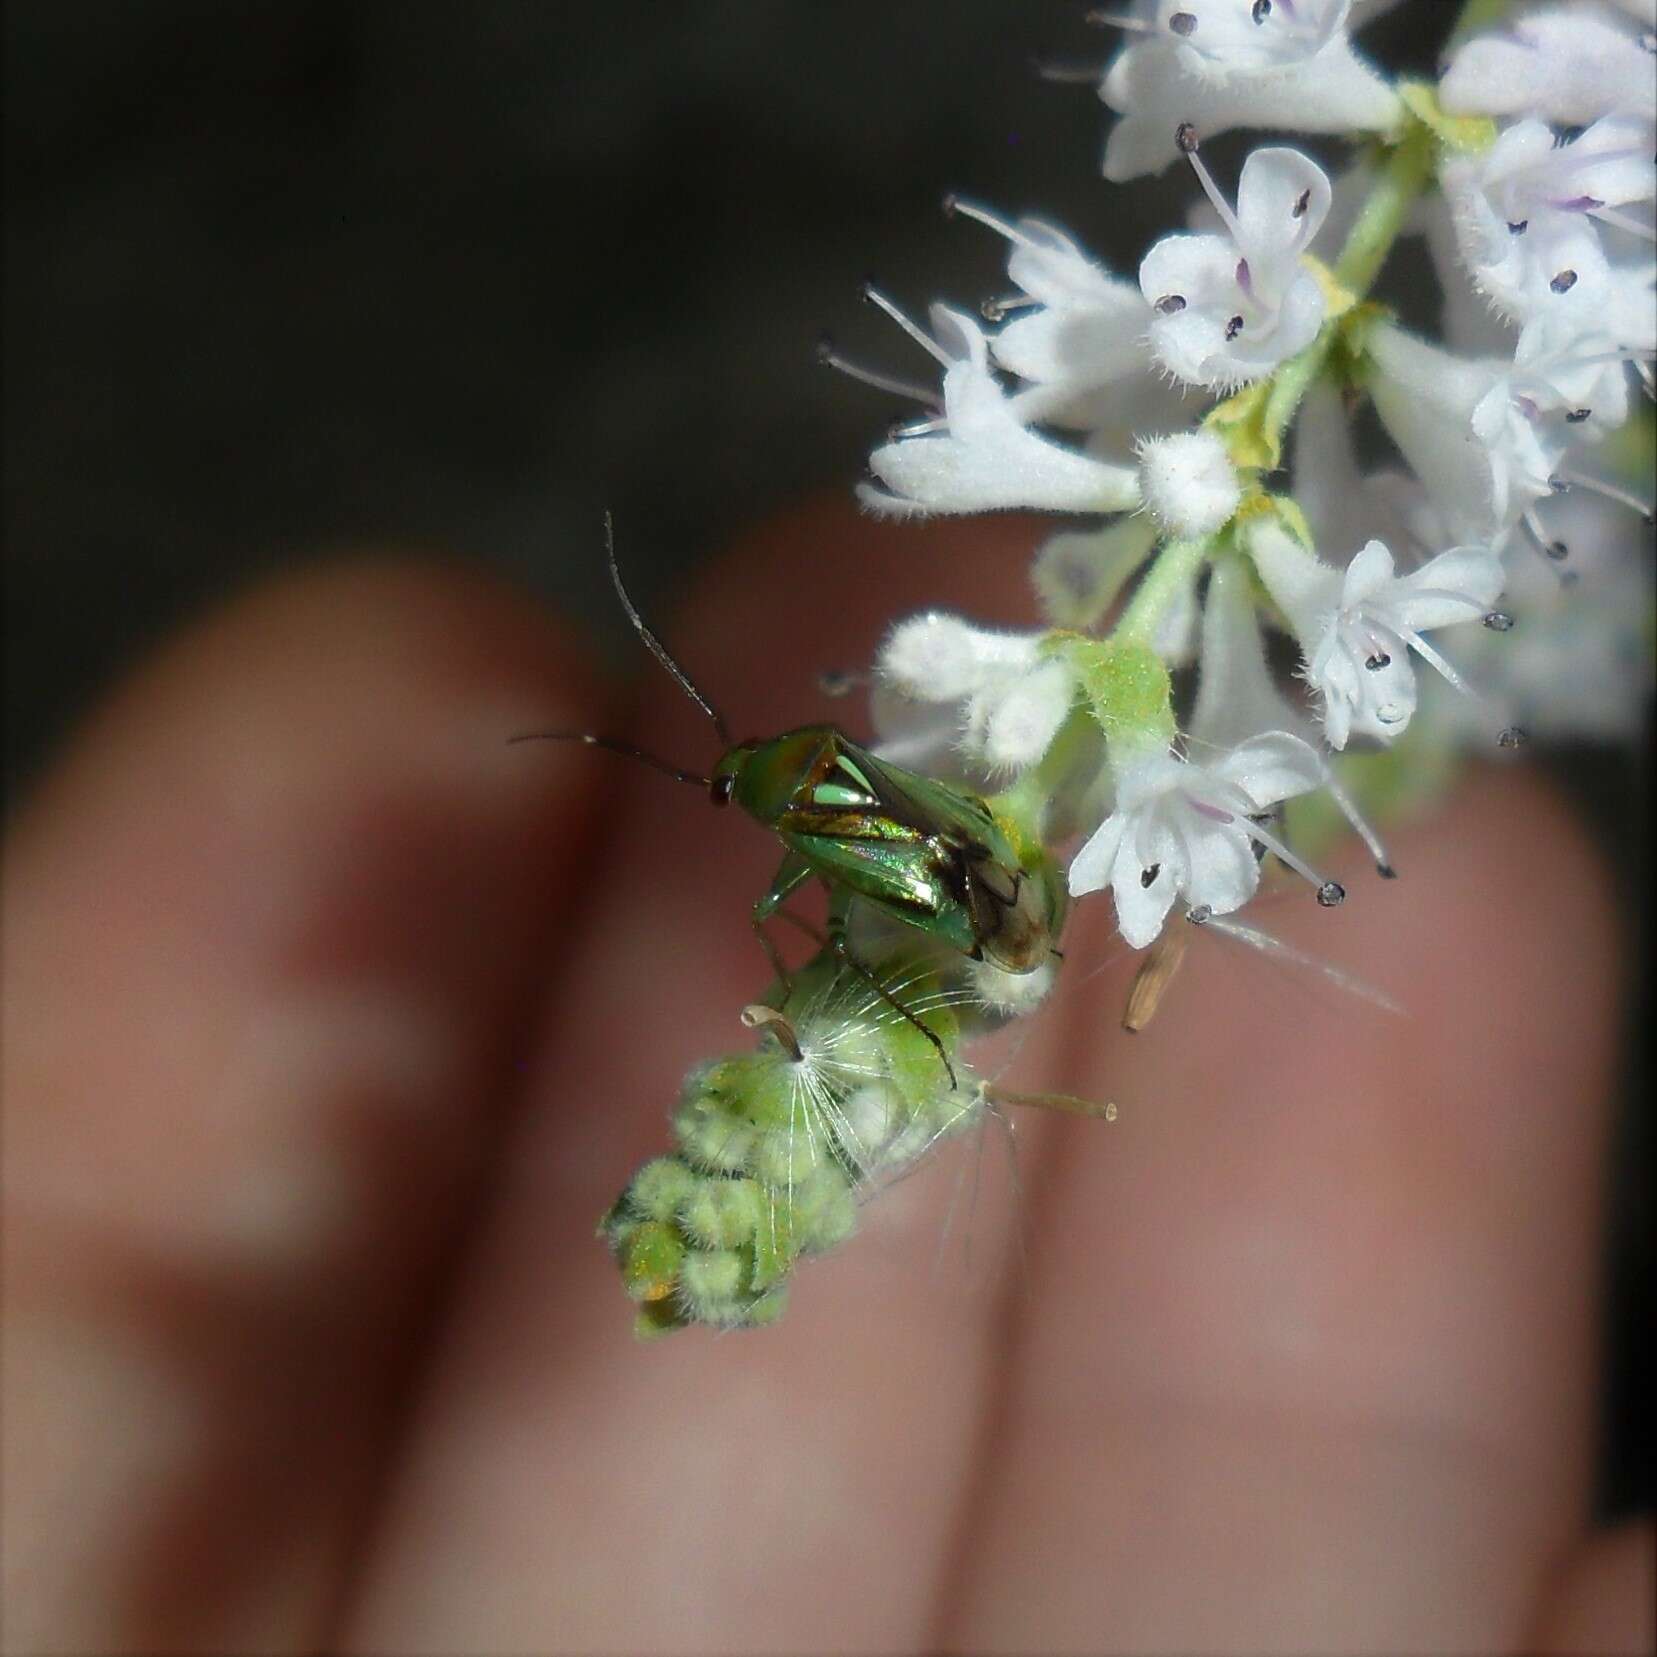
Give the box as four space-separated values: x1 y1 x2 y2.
0 560 616 1652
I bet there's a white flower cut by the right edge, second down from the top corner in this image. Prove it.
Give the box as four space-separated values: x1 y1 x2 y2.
1443 114 1657 329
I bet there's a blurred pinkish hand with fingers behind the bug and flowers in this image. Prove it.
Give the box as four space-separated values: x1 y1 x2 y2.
0 502 1650 1652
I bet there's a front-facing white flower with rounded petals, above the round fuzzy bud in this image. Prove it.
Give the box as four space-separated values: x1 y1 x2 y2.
1140 149 1331 391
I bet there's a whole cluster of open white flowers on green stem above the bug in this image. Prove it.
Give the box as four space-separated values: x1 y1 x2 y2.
830 0 1657 946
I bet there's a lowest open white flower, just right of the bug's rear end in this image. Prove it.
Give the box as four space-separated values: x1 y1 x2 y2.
1070 731 1345 949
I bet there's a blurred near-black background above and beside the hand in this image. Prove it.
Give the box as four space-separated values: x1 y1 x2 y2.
3 0 1652 1511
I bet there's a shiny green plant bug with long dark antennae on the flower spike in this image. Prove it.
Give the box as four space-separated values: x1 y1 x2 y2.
510 514 1065 1089
